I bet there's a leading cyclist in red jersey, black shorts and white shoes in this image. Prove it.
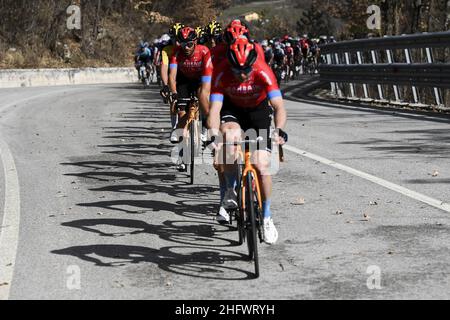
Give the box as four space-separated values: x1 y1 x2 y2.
208 36 288 244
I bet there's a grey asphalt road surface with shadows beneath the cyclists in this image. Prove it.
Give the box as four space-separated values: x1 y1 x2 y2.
0 80 450 300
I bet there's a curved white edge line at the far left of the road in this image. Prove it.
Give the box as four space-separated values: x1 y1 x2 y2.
0 139 20 300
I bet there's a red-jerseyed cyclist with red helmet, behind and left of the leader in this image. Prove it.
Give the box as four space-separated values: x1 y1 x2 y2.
169 27 213 171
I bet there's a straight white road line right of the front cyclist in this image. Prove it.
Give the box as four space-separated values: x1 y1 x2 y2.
284 146 450 213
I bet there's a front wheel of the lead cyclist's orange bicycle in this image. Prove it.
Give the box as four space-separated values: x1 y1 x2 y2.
245 173 259 278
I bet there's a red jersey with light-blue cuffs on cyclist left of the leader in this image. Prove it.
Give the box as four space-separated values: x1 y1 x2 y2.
170 45 213 82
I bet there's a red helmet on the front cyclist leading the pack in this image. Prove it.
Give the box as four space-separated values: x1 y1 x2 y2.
227 36 258 70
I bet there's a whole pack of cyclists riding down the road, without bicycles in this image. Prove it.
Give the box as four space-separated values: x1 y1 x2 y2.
135 20 334 244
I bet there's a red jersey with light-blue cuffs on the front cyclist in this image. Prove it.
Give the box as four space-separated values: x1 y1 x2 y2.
211 56 282 108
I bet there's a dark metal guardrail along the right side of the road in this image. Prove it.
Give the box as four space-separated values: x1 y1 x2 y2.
319 32 450 108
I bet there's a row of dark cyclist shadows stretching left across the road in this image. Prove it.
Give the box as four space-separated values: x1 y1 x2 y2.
52 87 254 280
